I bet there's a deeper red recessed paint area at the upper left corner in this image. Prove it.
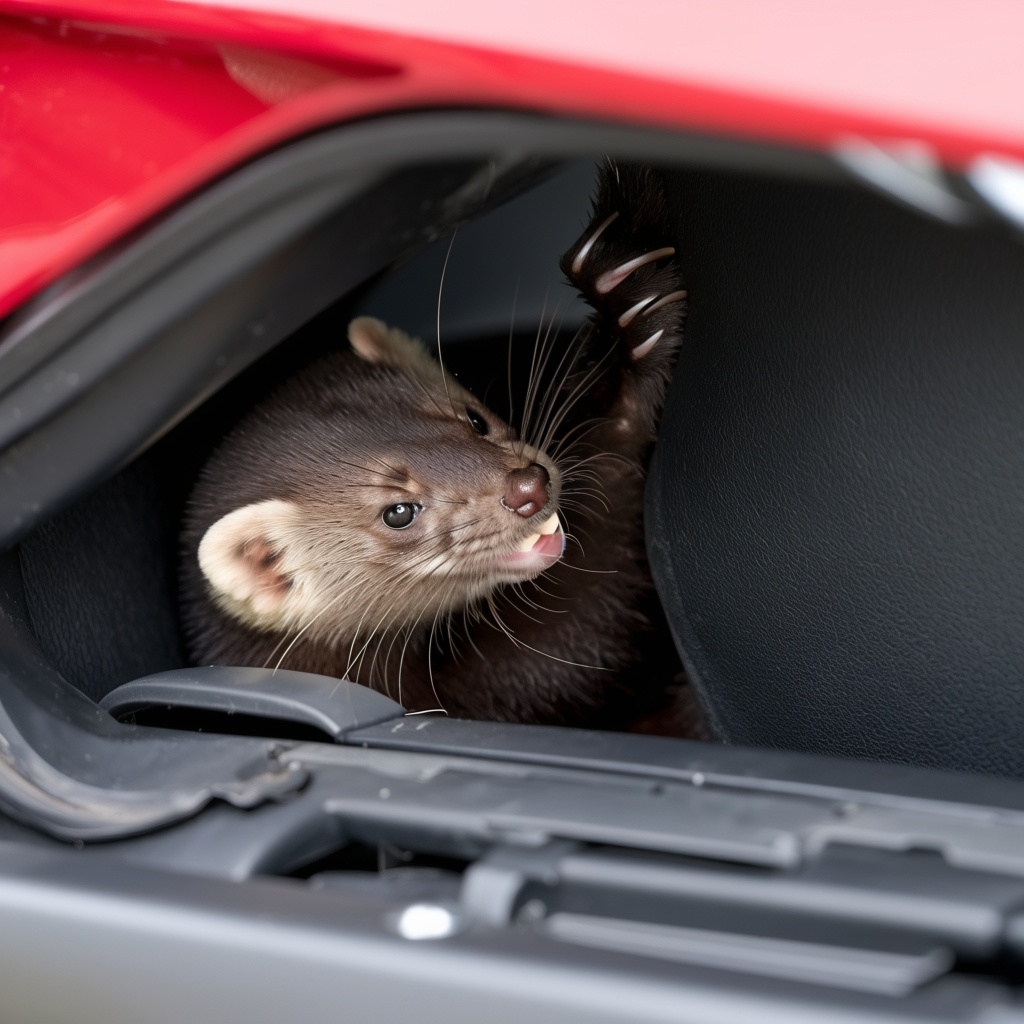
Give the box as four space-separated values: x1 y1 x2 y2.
0 17 407 315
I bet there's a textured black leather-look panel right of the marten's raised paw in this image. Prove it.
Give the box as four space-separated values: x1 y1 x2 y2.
647 167 1024 775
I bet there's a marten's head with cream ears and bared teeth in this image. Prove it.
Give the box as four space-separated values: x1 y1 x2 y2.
185 317 564 643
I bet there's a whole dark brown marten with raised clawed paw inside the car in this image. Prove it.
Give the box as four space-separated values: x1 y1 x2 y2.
183 164 686 731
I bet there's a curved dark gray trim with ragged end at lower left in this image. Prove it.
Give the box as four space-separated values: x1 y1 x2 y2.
0 554 308 840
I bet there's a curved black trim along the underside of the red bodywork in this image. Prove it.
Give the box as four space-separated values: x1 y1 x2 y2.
0 112 842 545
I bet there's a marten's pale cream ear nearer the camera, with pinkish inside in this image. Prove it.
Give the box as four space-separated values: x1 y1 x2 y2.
199 500 299 629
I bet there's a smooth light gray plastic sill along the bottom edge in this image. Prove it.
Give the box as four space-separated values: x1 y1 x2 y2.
0 845 1021 1024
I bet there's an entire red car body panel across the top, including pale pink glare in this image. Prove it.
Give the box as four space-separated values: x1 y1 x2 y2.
0 0 1024 315
